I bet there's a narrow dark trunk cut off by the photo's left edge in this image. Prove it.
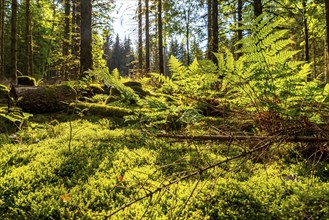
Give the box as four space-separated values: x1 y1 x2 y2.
0 0 5 80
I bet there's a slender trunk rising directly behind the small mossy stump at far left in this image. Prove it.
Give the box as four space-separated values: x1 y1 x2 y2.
25 0 33 76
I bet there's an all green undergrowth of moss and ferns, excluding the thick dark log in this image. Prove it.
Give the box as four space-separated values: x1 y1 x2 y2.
0 15 329 219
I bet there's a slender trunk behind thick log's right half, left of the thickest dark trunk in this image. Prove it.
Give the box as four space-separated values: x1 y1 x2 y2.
63 0 71 80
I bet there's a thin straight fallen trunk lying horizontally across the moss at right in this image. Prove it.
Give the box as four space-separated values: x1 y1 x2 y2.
155 134 329 143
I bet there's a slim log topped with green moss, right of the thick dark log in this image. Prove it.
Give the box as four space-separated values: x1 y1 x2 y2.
70 102 133 118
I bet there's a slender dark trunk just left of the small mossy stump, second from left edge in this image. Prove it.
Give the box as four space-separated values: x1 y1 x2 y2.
9 0 17 84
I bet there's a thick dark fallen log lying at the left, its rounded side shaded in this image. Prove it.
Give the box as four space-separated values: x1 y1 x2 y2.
8 85 77 114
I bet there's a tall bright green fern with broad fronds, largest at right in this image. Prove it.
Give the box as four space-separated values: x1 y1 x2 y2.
216 16 321 120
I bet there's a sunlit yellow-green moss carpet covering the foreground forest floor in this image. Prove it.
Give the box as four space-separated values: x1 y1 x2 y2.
0 78 329 219
